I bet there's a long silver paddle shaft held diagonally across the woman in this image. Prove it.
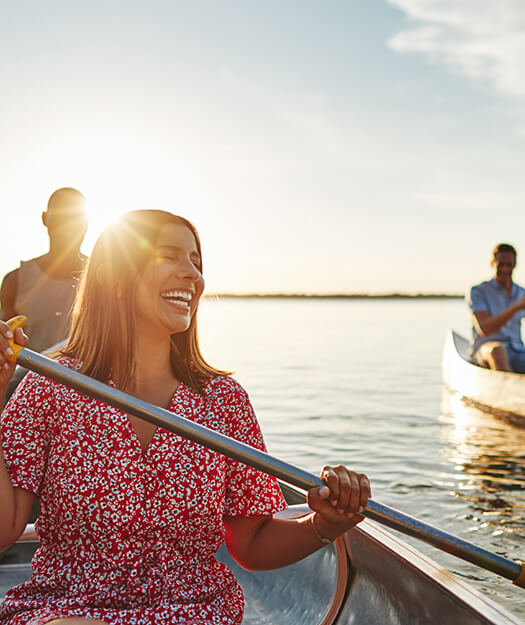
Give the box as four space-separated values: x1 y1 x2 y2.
5 334 525 588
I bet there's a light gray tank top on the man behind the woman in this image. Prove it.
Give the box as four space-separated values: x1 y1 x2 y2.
15 259 77 352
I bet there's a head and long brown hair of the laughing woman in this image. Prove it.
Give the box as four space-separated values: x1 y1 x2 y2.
65 210 219 390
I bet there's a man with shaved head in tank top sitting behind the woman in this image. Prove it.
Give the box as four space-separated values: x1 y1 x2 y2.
0 188 87 351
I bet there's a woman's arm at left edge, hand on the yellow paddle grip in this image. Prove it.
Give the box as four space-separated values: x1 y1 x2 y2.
0 321 35 551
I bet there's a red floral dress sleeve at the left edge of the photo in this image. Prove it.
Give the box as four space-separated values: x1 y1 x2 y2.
0 372 55 496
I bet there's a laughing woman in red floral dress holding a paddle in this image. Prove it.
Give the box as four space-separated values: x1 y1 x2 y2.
0 211 370 625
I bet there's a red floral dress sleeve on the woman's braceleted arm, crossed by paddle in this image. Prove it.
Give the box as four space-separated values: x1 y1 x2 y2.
224 380 286 517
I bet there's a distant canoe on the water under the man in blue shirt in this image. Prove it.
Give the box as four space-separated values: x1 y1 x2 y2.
442 330 525 426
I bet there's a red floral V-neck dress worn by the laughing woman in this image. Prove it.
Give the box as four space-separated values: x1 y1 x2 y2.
0 358 286 625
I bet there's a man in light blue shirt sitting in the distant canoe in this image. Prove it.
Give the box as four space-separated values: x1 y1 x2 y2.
468 243 525 373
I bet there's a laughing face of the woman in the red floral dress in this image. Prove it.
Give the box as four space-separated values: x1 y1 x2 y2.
135 223 204 335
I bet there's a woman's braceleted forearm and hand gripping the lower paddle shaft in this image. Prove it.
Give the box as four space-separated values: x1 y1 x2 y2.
225 465 370 570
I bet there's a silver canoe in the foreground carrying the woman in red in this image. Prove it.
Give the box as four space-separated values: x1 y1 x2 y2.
0 486 523 625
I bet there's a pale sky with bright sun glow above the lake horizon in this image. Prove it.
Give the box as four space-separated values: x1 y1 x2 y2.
0 0 525 293
